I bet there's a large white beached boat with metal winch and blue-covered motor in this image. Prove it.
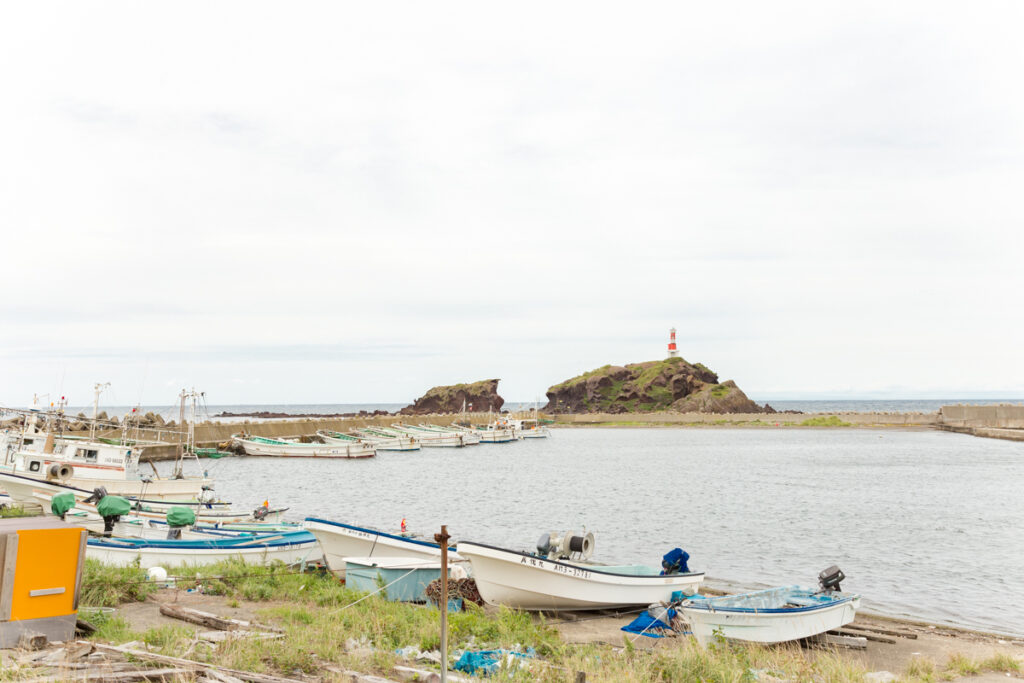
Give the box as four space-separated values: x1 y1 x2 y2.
458 537 703 611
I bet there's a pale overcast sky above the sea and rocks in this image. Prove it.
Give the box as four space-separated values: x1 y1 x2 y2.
0 0 1024 405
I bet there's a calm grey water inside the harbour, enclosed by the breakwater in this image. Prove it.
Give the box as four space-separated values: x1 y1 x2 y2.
153 429 1024 634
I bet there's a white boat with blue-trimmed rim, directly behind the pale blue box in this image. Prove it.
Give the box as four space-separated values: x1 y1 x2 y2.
302 517 465 577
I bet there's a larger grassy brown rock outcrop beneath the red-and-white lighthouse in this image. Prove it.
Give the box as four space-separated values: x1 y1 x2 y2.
544 357 774 413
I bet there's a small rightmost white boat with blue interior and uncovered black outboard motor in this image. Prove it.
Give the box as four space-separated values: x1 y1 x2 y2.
678 586 860 645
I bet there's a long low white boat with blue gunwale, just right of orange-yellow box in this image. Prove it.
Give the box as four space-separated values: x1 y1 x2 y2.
86 531 321 568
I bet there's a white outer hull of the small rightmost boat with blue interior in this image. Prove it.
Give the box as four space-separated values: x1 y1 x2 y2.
679 595 860 645
